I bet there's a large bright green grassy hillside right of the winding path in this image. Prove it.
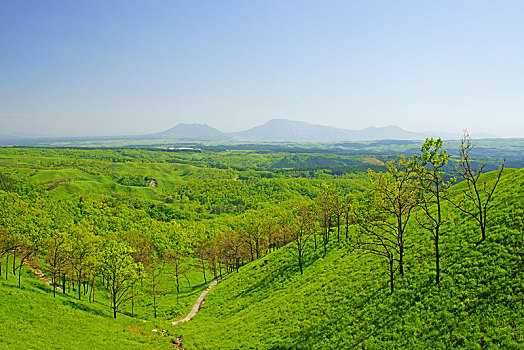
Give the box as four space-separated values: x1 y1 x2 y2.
176 170 524 349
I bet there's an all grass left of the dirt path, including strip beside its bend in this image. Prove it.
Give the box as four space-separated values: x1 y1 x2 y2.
0 254 215 349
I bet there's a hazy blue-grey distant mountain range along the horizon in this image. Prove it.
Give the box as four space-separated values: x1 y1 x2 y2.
0 119 494 146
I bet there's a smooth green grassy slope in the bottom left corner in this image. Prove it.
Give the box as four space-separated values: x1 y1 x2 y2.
0 273 172 349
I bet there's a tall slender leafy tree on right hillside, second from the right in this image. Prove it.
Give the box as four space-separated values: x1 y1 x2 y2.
414 138 454 284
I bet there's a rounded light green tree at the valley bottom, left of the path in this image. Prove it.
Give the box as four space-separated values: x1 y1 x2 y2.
99 238 139 318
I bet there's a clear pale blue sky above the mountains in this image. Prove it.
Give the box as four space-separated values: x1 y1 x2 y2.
0 0 524 137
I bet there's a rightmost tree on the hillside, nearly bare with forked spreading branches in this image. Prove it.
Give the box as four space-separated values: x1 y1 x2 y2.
452 131 506 242
